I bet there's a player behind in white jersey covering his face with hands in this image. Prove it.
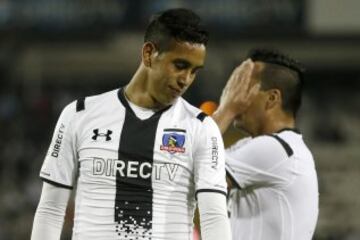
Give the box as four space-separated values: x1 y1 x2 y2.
213 49 318 240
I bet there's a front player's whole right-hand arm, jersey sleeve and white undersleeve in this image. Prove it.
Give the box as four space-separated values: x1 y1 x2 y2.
194 117 231 240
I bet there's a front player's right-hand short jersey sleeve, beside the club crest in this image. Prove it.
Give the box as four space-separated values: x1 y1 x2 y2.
193 117 227 195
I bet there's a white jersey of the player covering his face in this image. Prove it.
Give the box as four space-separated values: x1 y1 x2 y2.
226 129 319 240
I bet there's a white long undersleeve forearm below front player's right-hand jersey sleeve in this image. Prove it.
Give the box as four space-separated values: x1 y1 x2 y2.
198 192 231 240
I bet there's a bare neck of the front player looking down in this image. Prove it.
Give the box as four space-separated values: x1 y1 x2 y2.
124 66 162 109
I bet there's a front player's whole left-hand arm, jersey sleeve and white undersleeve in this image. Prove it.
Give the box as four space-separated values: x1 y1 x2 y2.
31 102 81 240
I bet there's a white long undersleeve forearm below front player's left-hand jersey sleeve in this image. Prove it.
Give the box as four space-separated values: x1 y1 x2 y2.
31 183 71 240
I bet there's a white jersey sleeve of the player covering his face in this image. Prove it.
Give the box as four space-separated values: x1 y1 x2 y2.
226 136 291 188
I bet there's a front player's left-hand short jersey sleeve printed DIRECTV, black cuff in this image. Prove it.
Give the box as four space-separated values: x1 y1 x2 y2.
40 102 77 189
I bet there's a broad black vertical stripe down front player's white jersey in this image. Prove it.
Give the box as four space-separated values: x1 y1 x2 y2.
115 90 164 239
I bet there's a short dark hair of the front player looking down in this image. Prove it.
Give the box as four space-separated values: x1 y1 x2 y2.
144 8 209 52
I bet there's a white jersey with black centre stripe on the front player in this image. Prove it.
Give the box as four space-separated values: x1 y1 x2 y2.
40 89 226 240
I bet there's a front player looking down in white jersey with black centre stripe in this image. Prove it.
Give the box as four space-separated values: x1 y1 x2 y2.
32 9 231 240
